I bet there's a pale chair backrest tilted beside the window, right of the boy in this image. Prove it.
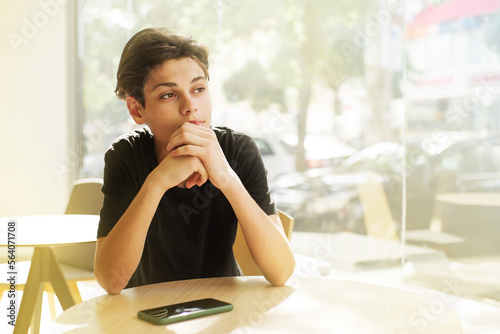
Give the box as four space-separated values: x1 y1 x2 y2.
358 173 399 240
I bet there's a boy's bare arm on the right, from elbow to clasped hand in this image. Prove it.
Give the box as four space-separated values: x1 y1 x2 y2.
168 124 295 286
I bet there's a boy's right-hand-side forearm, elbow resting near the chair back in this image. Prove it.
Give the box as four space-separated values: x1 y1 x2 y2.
223 176 295 286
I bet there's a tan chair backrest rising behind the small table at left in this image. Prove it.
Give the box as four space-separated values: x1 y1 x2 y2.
65 178 104 215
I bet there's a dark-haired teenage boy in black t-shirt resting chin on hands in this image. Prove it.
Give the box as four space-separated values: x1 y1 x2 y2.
95 28 295 294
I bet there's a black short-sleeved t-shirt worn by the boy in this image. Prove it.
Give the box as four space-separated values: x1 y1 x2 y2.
97 127 277 287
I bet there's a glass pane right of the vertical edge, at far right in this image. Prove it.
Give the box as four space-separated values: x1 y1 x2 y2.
405 1 500 305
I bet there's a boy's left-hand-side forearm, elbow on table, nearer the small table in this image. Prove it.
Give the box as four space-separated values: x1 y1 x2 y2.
95 176 163 294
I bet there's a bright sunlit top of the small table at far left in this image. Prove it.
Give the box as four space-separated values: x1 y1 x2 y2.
0 215 99 247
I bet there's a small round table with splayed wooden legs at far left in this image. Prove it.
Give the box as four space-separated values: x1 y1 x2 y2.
0 215 99 333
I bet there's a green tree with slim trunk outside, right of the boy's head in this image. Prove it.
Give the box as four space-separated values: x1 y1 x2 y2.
219 0 370 171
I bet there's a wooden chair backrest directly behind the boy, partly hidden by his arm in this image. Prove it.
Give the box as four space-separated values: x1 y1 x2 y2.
233 211 294 276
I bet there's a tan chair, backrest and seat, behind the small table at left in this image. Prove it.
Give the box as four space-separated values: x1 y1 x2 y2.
53 178 104 271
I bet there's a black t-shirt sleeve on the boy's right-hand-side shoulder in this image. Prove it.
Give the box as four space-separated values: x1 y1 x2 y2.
233 136 278 215
